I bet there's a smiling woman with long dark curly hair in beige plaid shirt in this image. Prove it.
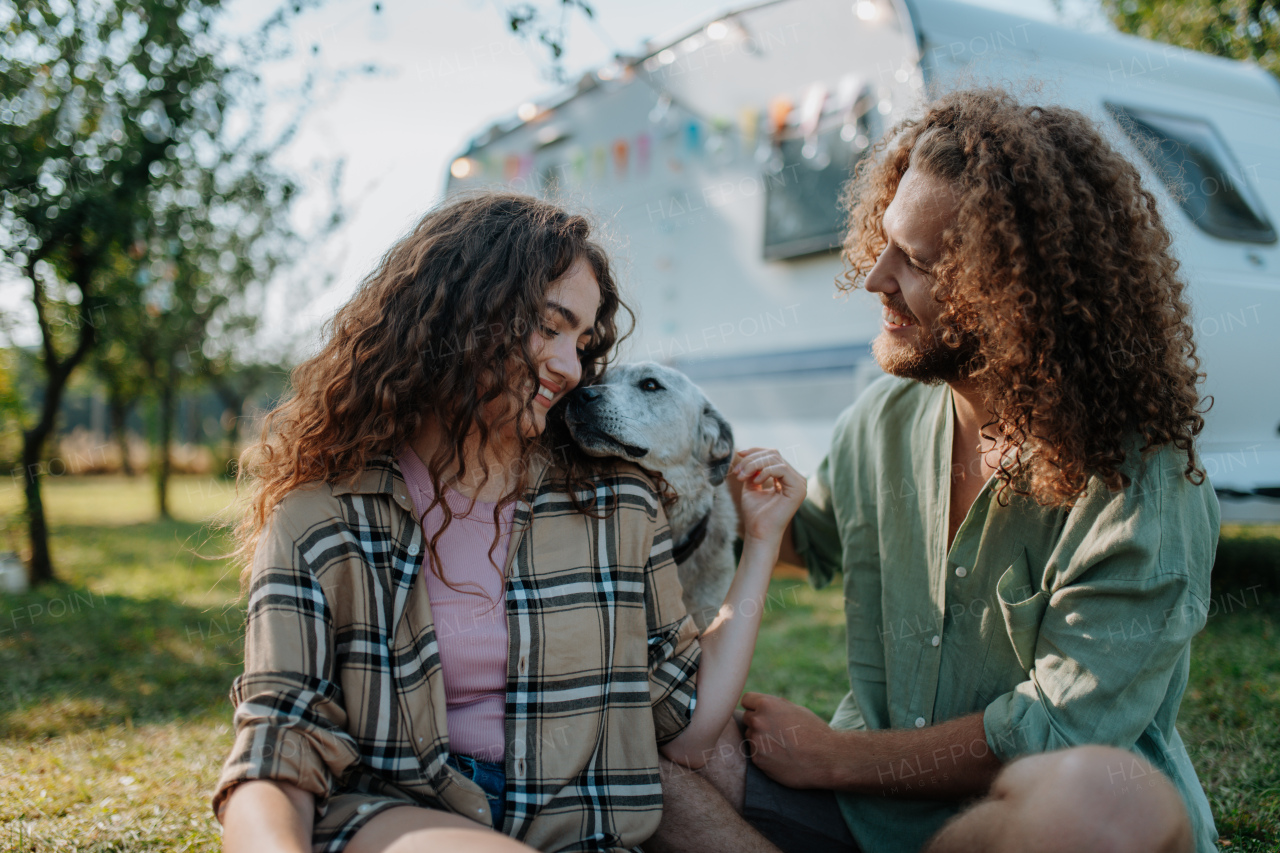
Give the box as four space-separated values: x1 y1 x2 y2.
214 193 805 853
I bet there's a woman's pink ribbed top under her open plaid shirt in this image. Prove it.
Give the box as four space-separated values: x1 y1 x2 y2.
399 444 516 762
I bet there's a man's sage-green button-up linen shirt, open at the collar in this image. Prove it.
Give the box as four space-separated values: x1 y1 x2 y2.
794 377 1219 853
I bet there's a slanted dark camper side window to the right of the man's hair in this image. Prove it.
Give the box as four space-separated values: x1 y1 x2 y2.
1106 104 1276 243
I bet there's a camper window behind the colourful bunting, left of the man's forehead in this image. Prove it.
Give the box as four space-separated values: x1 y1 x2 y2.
762 122 876 260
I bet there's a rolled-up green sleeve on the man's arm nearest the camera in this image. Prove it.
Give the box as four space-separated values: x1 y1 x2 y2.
983 461 1217 762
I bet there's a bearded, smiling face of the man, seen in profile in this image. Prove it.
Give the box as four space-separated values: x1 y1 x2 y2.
865 168 974 382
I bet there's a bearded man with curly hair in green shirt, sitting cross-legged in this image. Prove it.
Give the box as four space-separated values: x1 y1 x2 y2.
646 90 1219 853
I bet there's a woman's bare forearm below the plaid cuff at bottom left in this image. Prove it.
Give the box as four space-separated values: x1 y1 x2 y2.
218 779 315 853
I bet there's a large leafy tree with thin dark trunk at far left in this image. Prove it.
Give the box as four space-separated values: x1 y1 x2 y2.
0 0 320 584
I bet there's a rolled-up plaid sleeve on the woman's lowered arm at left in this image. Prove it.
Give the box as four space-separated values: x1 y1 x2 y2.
212 511 358 813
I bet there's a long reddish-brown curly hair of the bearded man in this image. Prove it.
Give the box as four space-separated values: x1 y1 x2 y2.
837 88 1204 506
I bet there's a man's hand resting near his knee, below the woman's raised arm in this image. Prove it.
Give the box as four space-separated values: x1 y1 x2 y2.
742 693 847 788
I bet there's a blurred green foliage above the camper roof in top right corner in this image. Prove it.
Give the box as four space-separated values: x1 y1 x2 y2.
1102 0 1280 77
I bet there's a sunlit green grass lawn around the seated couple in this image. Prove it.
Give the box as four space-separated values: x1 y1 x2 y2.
0 478 1280 852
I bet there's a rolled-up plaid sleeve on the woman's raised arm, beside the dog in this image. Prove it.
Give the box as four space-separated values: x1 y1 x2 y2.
644 510 701 745
